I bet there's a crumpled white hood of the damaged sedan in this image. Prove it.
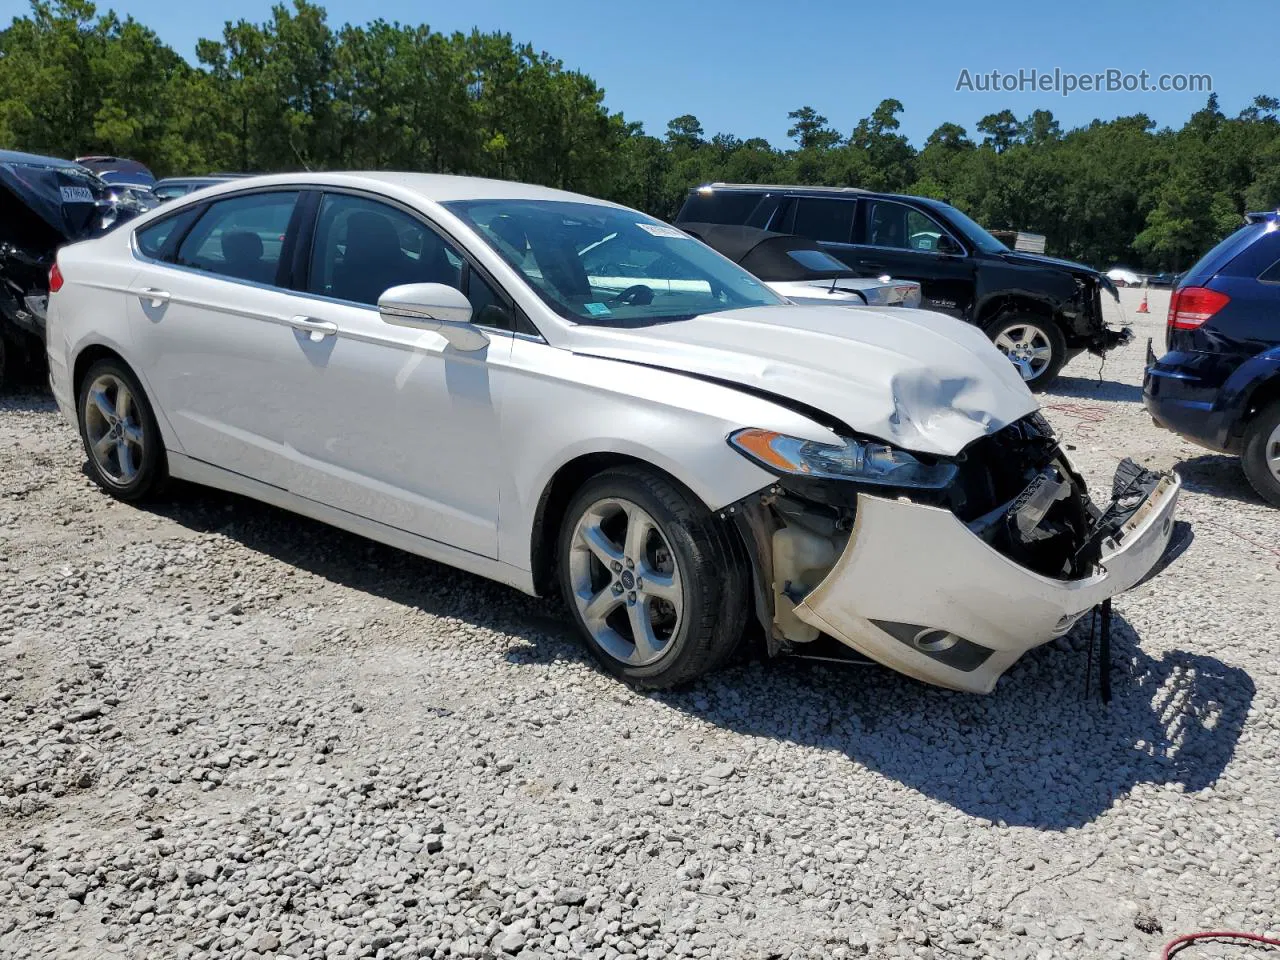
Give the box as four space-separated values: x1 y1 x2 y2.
567 306 1039 456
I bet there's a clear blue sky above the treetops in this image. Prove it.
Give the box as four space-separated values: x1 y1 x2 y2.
37 0 1280 146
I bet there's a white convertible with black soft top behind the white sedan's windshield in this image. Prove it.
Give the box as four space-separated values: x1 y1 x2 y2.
680 223 920 307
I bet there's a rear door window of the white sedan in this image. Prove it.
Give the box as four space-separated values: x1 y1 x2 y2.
178 191 298 283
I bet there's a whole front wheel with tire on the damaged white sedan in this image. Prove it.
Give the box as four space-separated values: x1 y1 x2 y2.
557 467 748 689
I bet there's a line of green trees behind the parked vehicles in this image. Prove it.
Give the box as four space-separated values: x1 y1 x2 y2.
0 0 1280 269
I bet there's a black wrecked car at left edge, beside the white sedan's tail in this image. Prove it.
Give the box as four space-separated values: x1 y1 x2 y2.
0 151 145 384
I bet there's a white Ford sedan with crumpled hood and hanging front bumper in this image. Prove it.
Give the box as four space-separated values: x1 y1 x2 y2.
49 174 1179 692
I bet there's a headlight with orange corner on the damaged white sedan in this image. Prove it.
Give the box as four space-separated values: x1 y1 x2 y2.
728 429 956 490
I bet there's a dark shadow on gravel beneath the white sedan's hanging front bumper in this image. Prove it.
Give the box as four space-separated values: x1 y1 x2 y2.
637 616 1254 831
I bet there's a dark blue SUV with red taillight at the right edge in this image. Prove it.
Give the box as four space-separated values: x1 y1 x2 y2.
1142 211 1280 507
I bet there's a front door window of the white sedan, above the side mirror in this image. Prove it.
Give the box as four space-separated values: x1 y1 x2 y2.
308 193 512 328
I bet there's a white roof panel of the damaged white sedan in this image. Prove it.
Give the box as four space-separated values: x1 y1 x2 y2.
183 172 620 206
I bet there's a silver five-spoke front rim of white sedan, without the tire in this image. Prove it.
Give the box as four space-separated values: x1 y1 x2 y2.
568 498 685 667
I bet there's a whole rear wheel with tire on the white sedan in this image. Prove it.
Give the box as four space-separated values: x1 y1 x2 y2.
76 360 168 503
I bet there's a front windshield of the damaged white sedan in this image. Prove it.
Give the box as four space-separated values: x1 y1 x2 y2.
444 200 786 326
